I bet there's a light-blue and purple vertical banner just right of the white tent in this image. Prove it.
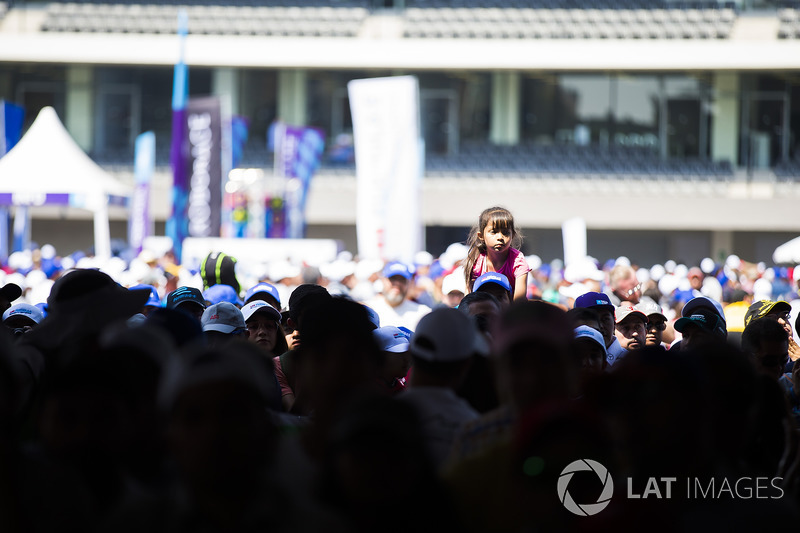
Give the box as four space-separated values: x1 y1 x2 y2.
128 131 156 255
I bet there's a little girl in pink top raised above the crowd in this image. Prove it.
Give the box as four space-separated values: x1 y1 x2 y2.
464 207 530 300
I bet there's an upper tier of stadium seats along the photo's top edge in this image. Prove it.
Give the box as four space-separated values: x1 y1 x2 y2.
36 0 736 39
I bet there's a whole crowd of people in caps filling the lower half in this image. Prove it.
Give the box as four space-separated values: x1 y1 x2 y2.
0 208 800 533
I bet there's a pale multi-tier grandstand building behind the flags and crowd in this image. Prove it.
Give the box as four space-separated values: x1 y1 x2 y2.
0 0 800 265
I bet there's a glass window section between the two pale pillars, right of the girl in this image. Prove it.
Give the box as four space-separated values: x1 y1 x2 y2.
521 73 696 156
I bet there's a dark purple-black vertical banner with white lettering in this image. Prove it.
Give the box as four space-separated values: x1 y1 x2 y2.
185 96 222 237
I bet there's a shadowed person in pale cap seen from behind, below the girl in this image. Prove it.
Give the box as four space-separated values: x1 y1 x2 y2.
397 307 488 467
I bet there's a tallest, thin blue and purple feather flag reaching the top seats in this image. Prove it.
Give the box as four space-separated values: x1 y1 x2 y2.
166 9 189 262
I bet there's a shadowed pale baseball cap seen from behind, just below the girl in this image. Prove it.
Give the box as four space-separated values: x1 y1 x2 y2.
411 308 489 363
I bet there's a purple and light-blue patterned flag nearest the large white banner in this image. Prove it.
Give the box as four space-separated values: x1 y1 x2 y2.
275 126 325 239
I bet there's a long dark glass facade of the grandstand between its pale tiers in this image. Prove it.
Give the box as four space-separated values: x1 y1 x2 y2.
0 64 800 168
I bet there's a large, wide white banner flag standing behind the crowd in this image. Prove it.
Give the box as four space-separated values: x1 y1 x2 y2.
347 76 424 264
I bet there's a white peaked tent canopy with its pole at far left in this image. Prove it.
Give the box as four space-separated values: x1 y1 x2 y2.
0 107 131 257
